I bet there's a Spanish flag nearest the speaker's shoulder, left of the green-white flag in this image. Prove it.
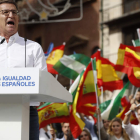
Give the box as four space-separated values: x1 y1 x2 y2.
46 45 65 74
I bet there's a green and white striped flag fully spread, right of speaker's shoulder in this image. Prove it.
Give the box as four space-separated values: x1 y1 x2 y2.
53 54 90 80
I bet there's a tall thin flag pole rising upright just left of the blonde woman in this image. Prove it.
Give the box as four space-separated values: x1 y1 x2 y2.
91 58 101 140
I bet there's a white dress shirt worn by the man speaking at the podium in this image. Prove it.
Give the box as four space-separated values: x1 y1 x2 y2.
0 33 47 106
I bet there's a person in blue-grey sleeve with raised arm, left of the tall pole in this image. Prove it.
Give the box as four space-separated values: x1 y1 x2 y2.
79 113 98 140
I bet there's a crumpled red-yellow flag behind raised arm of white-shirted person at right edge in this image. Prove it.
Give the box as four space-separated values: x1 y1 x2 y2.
116 96 138 125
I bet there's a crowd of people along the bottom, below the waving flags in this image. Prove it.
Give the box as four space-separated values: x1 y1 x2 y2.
39 90 140 140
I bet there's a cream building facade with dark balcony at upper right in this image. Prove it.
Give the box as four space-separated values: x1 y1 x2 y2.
100 0 140 98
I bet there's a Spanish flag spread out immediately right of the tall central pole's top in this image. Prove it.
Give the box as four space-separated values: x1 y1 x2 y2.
92 51 123 91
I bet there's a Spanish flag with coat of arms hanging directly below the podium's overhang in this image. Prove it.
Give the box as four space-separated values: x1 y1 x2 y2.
38 103 69 129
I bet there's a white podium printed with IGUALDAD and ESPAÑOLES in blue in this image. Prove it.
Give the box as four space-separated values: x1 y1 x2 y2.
0 68 72 140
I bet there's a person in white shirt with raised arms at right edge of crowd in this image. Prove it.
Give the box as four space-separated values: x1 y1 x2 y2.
123 100 140 140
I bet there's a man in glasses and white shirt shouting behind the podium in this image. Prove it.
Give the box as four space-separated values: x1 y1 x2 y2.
0 0 47 140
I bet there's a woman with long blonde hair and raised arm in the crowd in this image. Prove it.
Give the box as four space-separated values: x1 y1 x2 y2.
96 108 130 140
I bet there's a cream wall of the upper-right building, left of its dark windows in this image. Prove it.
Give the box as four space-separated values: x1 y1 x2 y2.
103 0 122 64
